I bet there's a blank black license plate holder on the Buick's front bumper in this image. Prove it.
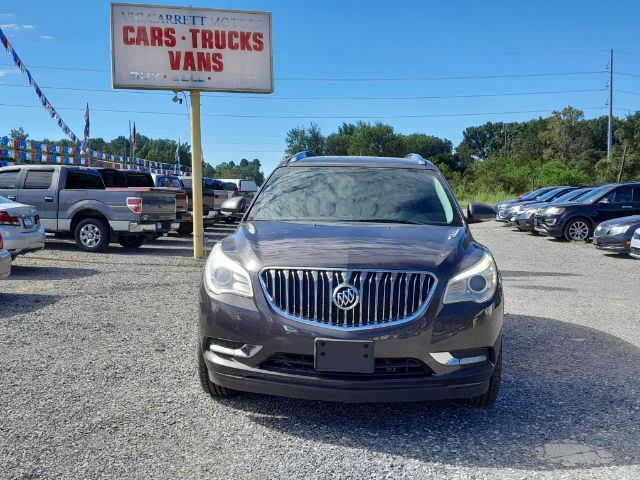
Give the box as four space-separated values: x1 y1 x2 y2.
314 338 375 373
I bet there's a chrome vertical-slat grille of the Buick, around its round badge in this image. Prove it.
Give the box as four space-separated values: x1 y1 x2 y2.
260 268 436 329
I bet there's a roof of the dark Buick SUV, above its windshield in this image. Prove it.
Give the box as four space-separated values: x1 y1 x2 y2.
280 154 437 170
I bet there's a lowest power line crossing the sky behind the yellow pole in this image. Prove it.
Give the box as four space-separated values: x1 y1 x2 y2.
0 103 604 120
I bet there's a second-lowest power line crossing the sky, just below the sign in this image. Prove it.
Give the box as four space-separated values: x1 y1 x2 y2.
0 83 606 101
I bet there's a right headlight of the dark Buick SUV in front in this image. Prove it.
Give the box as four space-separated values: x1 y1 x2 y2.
442 253 498 303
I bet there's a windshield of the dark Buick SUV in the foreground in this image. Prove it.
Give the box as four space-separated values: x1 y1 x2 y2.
248 167 462 226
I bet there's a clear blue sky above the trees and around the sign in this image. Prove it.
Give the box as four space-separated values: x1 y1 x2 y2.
0 0 640 172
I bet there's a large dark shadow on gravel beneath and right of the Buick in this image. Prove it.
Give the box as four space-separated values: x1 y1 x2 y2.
213 316 640 470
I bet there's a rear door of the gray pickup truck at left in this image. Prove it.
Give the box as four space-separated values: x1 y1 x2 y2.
17 168 58 231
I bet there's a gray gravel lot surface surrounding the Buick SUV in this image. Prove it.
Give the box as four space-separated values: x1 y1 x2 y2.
0 222 640 479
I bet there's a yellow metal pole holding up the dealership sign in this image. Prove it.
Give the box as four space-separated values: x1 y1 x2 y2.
189 90 204 258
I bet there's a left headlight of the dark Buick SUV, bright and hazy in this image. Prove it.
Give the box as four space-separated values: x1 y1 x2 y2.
204 243 253 297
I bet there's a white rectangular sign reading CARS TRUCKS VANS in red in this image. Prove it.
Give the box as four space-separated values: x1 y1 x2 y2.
111 3 273 93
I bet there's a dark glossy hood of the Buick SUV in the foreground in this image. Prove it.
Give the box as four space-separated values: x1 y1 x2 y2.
222 221 485 274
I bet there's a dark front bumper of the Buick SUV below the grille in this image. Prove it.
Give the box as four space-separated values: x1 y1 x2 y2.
200 287 503 402
